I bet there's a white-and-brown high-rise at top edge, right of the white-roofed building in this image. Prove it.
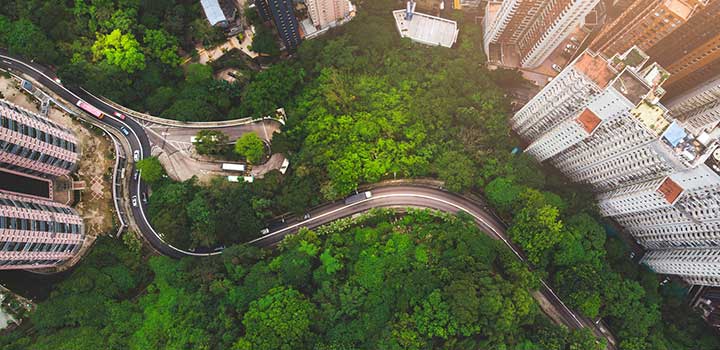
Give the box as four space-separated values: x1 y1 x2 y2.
483 0 599 68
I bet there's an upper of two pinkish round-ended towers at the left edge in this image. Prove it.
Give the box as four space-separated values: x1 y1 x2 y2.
0 100 80 176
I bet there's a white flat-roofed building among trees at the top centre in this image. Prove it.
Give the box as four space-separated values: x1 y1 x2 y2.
393 10 459 47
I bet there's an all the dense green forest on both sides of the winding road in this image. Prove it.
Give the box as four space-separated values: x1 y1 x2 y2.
0 0 720 350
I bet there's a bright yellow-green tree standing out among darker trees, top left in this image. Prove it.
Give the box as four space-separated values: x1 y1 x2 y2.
92 29 145 73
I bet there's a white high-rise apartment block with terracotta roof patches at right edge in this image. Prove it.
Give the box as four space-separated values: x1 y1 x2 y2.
511 47 720 285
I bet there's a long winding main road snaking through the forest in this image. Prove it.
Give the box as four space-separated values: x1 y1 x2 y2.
0 51 615 349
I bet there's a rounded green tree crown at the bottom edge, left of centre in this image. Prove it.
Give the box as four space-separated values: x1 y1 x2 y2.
239 287 314 350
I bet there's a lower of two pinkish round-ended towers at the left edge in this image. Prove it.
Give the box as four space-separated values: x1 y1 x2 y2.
0 191 85 270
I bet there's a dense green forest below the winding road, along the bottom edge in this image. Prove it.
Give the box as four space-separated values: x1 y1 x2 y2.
0 211 601 350
